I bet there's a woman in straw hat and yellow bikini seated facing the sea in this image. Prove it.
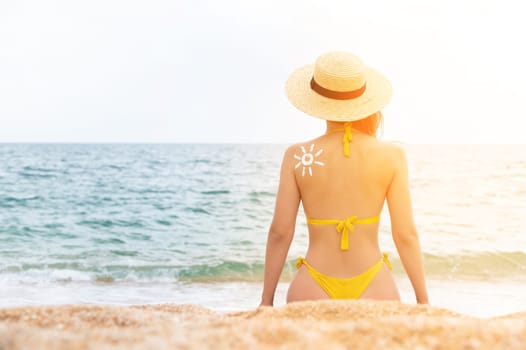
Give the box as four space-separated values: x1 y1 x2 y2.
261 52 428 306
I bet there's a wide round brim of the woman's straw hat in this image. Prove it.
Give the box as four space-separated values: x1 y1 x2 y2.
285 64 392 121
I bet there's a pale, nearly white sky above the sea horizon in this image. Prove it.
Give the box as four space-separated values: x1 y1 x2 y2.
0 0 526 144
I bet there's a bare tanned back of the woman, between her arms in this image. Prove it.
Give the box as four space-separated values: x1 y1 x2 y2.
289 129 396 277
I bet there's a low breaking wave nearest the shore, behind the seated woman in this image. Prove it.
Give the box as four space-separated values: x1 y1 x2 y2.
0 250 526 283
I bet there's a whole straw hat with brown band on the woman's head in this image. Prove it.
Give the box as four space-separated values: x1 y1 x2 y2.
285 51 392 121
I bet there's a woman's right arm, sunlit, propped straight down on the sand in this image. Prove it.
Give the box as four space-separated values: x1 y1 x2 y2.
387 148 429 304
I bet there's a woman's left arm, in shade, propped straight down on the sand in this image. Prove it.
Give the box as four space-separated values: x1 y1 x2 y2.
260 148 300 306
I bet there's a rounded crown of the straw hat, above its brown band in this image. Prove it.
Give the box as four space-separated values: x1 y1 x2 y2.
314 51 365 92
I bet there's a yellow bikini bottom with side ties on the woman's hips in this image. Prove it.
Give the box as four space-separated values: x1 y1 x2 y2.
296 253 393 299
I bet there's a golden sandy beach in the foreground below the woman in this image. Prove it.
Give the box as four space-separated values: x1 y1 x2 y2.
0 301 526 350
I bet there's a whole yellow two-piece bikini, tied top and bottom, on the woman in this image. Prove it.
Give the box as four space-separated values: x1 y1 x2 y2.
296 123 393 299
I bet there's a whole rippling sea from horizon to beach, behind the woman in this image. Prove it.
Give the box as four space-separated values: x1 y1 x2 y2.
0 144 526 317
